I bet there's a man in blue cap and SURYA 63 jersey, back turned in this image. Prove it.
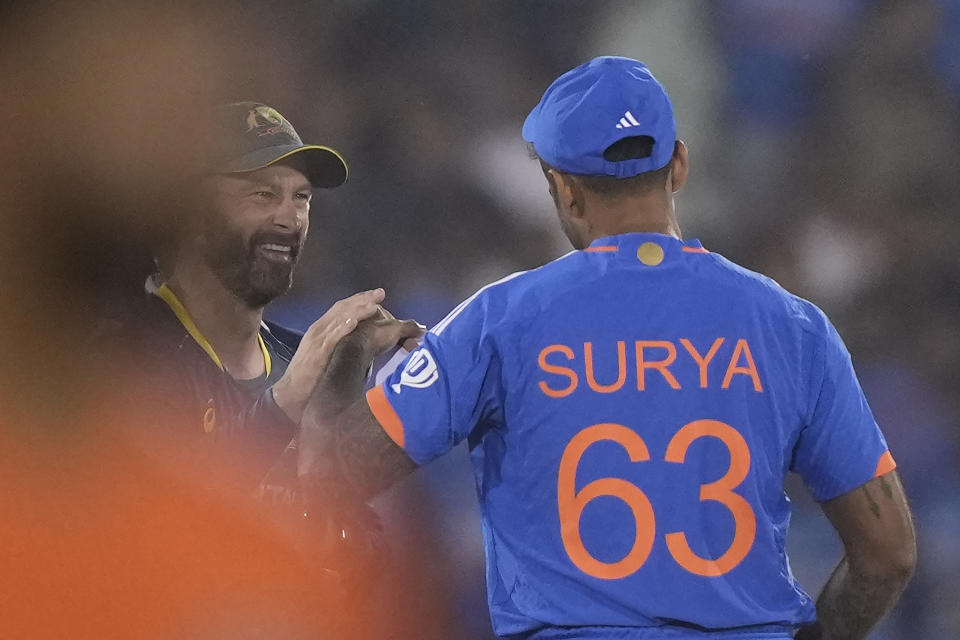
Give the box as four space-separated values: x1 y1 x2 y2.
300 57 915 640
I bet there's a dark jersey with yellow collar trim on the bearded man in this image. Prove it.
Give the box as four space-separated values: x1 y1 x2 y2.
122 286 383 584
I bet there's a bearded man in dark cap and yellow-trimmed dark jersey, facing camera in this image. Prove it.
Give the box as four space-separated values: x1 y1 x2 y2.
123 102 421 546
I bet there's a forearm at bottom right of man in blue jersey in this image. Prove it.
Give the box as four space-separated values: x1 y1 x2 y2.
796 558 910 640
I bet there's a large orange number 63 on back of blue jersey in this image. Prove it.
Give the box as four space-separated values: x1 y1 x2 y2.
557 420 757 580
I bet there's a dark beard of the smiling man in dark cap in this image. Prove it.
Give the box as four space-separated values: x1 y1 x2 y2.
204 214 300 309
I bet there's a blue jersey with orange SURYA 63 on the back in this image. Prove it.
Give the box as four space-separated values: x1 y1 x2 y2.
367 233 895 639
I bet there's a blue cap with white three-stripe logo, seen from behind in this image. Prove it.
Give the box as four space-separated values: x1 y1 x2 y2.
523 56 677 178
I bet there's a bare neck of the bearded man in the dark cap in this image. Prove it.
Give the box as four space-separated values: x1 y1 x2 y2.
166 265 265 379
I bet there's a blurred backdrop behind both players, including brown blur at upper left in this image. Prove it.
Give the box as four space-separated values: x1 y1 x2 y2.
0 0 960 640
